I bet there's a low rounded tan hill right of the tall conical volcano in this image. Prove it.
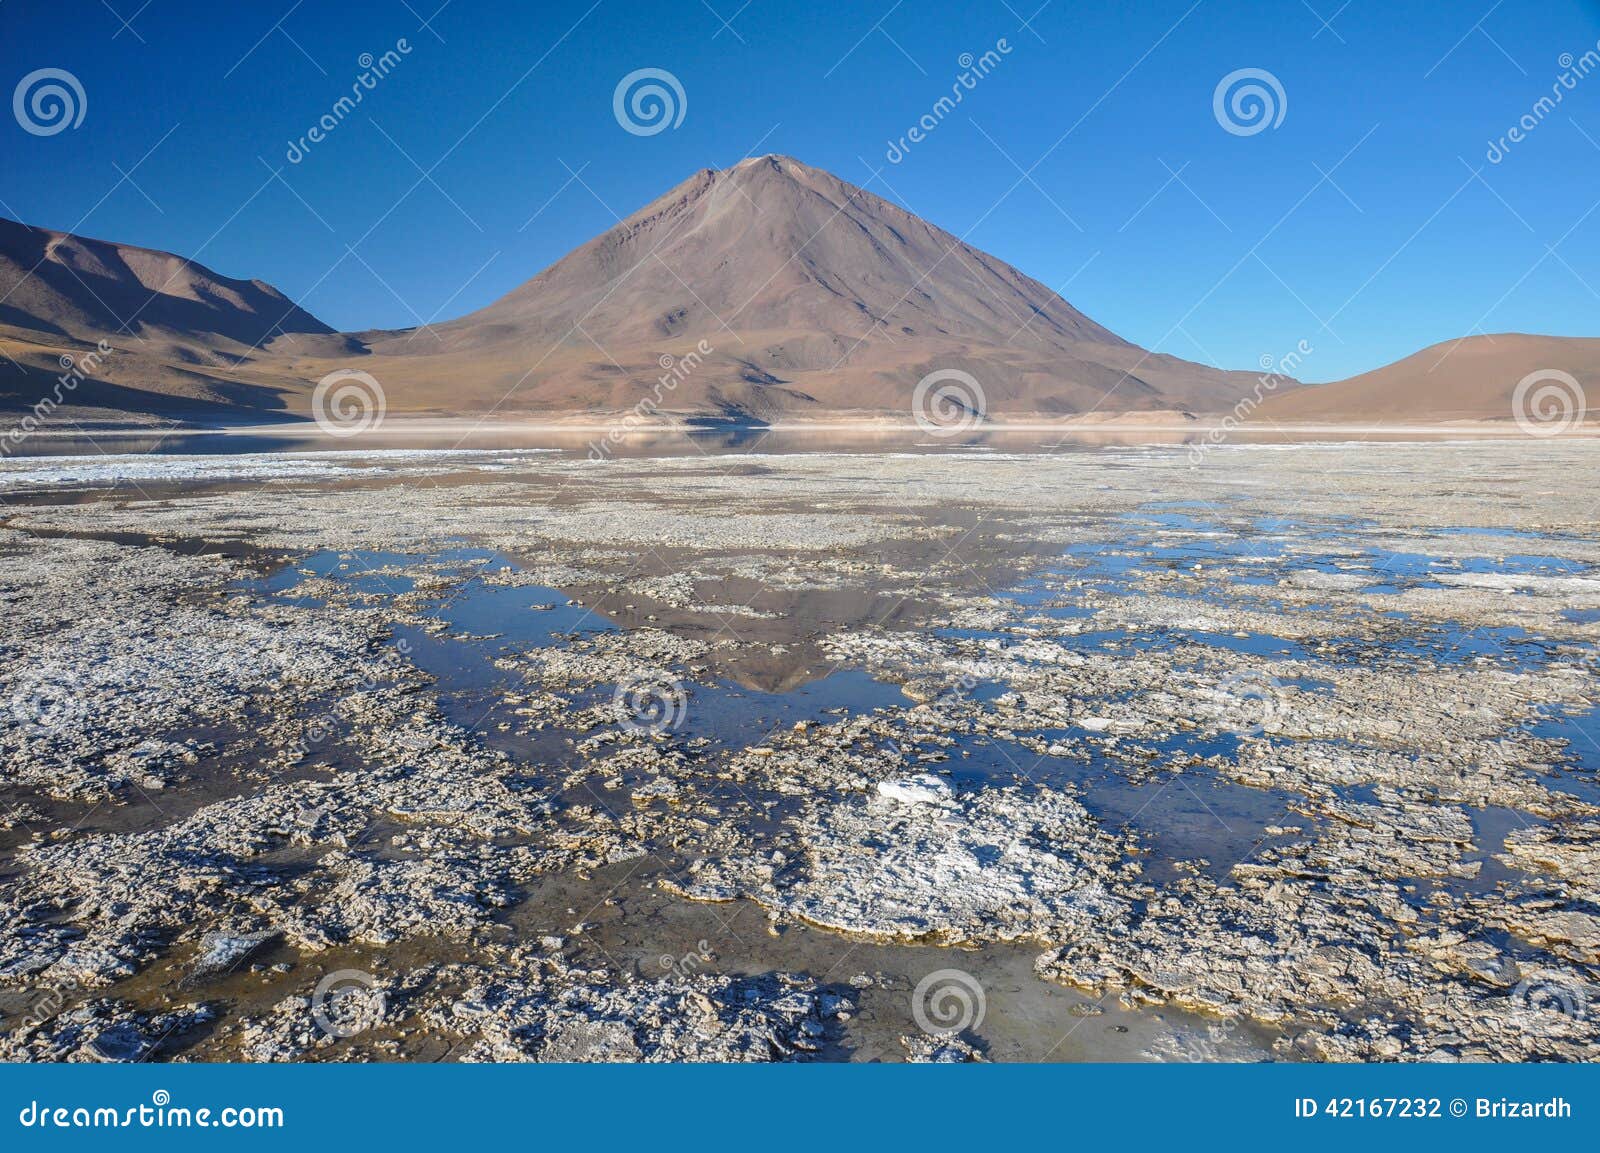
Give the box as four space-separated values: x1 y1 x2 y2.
1259 333 1600 424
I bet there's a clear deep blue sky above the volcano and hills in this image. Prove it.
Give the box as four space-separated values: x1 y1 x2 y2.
0 0 1600 381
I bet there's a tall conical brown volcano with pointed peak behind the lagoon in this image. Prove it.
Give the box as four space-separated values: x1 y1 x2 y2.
340 157 1286 419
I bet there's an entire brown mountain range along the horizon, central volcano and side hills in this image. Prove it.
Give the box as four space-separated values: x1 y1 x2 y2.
0 157 1600 424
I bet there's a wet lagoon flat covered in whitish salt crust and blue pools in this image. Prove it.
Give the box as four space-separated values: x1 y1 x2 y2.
0 440 1600 1060
